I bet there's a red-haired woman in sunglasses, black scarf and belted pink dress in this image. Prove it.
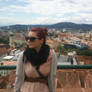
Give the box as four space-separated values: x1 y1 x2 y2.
14 28 57 92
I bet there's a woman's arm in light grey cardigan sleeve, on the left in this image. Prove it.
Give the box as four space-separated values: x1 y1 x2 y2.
14 52 24 92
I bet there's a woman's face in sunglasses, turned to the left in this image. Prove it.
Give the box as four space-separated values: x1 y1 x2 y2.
27 31 43 50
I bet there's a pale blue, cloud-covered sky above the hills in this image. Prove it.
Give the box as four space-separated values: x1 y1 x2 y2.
0 0 92 26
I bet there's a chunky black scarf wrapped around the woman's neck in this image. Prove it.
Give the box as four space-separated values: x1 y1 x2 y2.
24 45 50 67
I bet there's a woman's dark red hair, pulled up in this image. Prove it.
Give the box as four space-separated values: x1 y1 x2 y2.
29 27 48 44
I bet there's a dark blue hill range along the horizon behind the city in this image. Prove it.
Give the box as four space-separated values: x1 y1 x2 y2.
0 22 92 31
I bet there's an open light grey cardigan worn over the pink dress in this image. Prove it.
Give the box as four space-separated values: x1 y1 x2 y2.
14 50 57 92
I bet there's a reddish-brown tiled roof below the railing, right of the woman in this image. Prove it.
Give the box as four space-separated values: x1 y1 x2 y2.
56 69 92 92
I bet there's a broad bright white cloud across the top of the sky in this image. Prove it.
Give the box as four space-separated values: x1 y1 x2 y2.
0 0 92 15
